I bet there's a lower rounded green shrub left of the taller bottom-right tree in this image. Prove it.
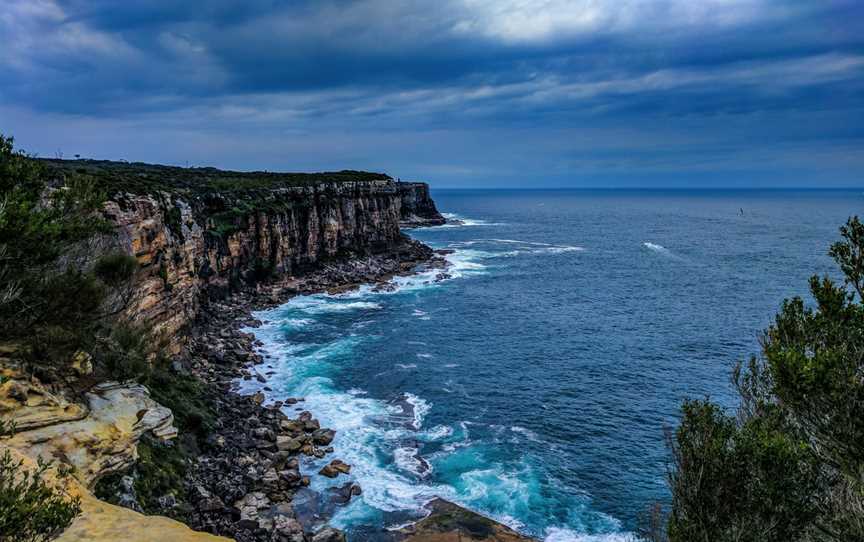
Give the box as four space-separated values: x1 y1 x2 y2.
668 401 815 542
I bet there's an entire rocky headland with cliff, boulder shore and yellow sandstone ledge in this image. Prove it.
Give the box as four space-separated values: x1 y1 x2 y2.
0 161 518 542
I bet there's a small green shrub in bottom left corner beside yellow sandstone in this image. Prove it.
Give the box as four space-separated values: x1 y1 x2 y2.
0 450 81 542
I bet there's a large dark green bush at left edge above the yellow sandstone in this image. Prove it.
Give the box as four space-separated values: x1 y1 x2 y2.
0 135 110 376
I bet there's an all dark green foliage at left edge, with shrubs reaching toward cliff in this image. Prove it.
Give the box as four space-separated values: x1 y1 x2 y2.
0 135 146 379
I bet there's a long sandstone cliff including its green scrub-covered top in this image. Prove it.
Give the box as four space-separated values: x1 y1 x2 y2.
38 160 444 344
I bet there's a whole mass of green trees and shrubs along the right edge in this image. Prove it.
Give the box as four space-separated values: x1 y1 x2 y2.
668 217 864 542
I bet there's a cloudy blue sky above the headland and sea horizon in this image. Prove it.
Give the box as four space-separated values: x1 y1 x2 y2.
0 0 864 188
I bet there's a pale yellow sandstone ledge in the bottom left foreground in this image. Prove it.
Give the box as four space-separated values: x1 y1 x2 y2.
0 357 228 542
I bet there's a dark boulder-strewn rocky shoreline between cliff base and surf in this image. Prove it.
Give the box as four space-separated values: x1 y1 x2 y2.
156 238 447 542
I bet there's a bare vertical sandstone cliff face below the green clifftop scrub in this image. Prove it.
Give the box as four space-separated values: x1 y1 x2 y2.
106 180 443 344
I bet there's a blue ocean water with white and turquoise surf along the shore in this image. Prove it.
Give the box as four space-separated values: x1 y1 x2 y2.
235 190 864 542
